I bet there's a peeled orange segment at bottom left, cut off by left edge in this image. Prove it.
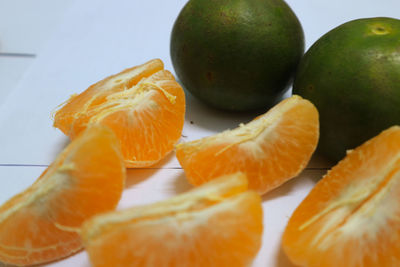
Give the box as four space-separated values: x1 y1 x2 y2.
0 126 125 266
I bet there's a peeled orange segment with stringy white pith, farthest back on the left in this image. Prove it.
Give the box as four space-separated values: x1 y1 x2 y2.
54 59 185 167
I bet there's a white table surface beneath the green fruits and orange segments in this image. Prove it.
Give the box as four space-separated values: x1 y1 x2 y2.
0 0 400 267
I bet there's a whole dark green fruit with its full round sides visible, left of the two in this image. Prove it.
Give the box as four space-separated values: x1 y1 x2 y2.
170 0 304 110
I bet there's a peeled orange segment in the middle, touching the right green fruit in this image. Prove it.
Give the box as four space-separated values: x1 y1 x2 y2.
176 96 319 194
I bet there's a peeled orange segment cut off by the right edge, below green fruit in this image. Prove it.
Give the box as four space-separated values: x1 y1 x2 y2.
282 126 400 267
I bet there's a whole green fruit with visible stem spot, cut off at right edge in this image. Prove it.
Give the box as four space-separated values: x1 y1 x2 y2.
293 17 400 161
